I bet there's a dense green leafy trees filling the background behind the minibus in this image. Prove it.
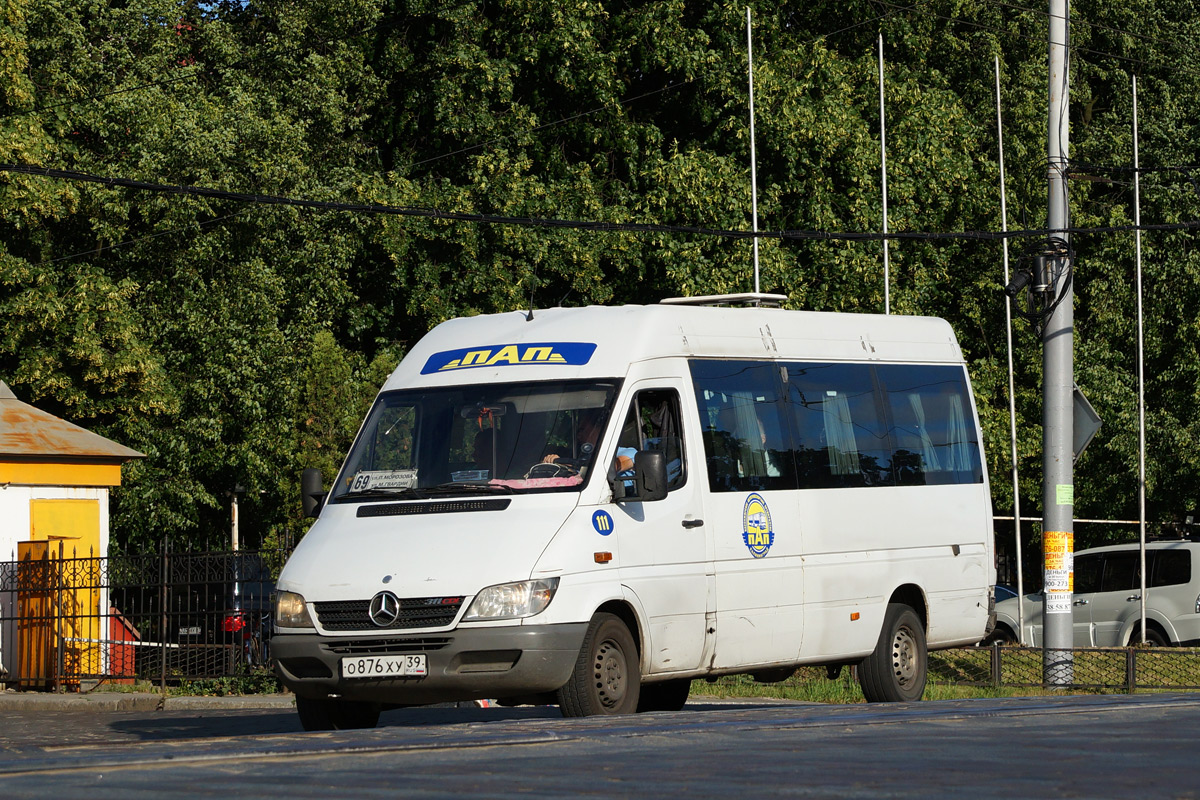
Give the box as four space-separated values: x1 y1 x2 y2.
0 0 1200 556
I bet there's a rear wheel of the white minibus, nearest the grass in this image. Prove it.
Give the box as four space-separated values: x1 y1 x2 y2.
858 603 929 703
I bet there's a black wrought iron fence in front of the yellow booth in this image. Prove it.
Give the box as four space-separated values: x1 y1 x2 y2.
0 542 287 691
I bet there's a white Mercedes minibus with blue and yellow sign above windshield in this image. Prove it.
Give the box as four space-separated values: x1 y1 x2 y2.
271 295 995 729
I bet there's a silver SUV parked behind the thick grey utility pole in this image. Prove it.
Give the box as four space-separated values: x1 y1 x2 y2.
985 541 1200 648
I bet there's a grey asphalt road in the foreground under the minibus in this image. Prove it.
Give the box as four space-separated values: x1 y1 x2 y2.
0 694 1200 800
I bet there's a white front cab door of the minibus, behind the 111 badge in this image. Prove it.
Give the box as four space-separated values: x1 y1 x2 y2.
612 379 712 674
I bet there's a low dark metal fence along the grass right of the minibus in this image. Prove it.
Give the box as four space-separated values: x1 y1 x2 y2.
929 645 1200 692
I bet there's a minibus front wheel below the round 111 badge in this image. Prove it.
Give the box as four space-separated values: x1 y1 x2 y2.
557 614 642 717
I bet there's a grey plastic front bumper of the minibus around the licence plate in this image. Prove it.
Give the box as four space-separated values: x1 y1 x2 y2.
271 622 588 705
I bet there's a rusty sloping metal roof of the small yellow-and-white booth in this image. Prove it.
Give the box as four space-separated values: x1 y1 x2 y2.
0 380 145 461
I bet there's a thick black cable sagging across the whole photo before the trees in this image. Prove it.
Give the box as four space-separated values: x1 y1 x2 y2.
9 164 1200 241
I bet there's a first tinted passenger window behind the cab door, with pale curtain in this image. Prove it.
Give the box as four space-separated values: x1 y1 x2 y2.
690 360 796 492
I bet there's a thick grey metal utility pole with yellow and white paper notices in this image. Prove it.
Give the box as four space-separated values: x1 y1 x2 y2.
1042 0 1086 686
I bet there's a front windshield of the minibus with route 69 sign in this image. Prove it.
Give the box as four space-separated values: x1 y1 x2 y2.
330 380 619 503
